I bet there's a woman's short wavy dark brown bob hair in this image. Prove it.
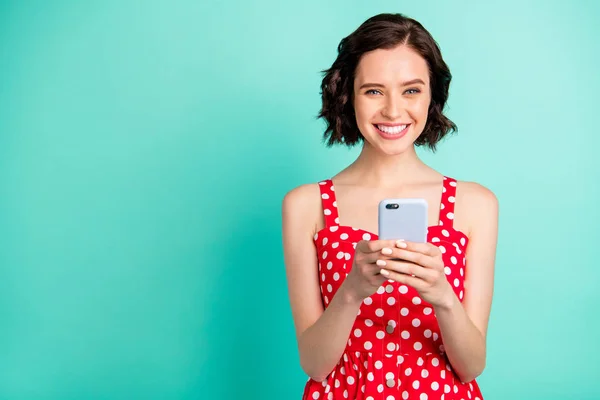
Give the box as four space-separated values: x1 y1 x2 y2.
317 14 457 151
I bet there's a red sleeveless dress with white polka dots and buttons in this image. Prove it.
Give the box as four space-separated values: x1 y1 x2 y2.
303 177 483 400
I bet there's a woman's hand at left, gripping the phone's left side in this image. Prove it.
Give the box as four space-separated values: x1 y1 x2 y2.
344 240 395 301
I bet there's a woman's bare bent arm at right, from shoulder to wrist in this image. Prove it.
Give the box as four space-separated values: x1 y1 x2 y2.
435 184 498 382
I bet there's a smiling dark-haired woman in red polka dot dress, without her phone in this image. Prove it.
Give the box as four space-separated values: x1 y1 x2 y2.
282 14 498 400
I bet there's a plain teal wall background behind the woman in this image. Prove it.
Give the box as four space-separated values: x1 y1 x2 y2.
0 0 600 400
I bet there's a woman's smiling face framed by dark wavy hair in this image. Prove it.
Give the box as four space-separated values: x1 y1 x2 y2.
353 45 431 155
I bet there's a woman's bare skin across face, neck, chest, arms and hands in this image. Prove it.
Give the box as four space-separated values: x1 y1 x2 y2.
282 46 498 382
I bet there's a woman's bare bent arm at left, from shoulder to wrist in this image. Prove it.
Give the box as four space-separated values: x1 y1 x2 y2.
282 185 362 381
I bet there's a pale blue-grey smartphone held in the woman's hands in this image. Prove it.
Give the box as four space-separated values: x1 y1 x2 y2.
378 198 428 243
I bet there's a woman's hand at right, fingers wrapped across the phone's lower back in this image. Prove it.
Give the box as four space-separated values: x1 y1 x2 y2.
376 240 454 307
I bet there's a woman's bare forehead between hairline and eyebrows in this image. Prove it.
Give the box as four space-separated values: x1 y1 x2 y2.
356 45 429 84
